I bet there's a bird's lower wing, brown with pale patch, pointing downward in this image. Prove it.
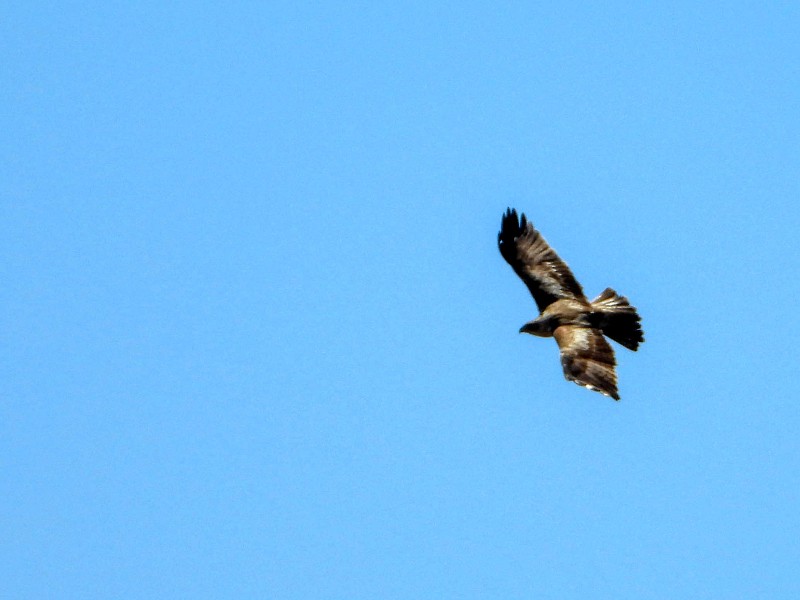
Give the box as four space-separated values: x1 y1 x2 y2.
553 325 619 400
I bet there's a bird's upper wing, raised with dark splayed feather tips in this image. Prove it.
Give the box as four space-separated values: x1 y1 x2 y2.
497 208 585 312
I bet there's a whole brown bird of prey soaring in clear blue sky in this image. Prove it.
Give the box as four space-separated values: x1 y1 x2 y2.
497 208 644 400
